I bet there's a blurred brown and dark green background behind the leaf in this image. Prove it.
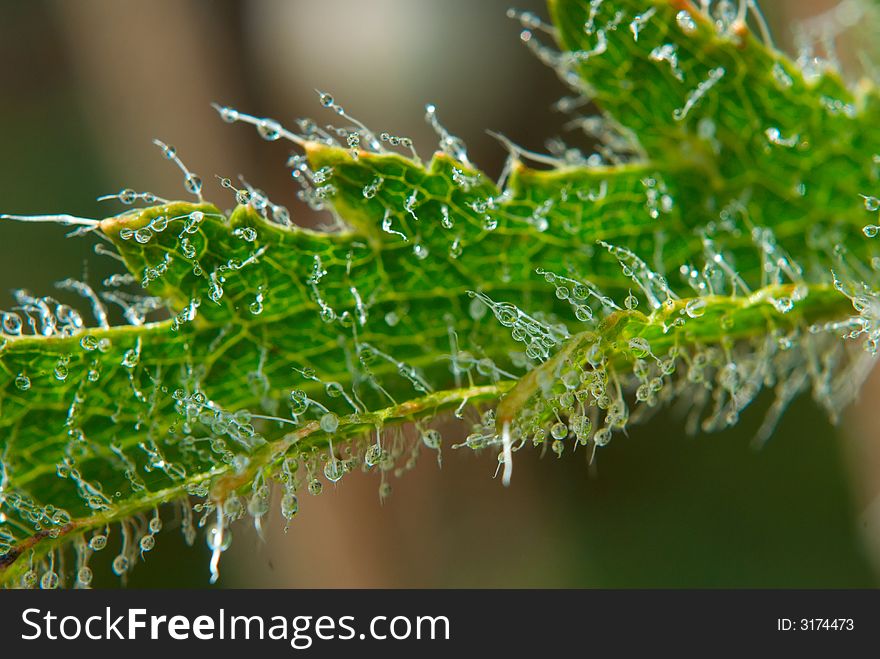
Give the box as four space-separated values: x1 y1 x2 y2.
0 0 880 587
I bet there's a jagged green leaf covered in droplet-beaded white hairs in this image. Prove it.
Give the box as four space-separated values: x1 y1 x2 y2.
0 0 880 588
